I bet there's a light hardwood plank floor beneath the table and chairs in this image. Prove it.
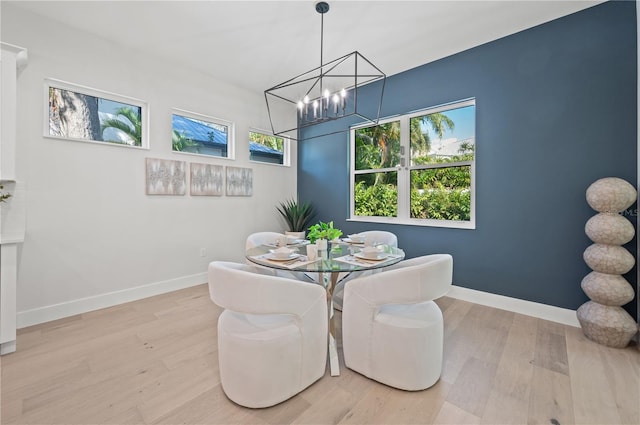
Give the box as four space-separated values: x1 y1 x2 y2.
0 285 640 425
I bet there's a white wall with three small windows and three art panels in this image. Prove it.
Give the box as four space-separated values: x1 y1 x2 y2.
1 3 296 326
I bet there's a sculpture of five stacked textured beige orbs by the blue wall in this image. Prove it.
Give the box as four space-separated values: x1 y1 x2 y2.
577 177 638 348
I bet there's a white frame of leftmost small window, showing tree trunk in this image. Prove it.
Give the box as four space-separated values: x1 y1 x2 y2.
42 78 149 150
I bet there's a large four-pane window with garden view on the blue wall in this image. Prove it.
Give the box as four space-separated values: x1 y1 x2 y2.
351 99 476 229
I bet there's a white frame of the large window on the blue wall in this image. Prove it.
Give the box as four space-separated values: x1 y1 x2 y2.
347 98 477 230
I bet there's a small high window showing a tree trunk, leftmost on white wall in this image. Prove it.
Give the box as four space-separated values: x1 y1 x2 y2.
45 79 148 147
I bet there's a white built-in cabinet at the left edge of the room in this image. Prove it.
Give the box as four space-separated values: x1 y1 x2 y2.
0 43 27 354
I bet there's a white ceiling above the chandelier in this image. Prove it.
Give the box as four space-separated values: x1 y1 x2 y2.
3 0 602 93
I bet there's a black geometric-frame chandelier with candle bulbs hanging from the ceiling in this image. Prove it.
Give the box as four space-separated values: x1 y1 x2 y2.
264 1 387 140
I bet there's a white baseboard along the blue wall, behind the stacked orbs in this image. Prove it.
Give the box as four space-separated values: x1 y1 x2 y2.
447 285 580 328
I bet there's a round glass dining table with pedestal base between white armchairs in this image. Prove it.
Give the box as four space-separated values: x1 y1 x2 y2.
246 240 404 376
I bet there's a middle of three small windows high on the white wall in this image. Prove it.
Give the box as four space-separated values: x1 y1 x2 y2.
171 109 234 158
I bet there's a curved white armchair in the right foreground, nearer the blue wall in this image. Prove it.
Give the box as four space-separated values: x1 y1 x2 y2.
342 254 453 391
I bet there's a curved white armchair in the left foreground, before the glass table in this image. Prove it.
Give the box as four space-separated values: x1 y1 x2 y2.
209 261 328 408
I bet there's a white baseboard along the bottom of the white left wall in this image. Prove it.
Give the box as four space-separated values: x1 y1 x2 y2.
17 272 207 329
